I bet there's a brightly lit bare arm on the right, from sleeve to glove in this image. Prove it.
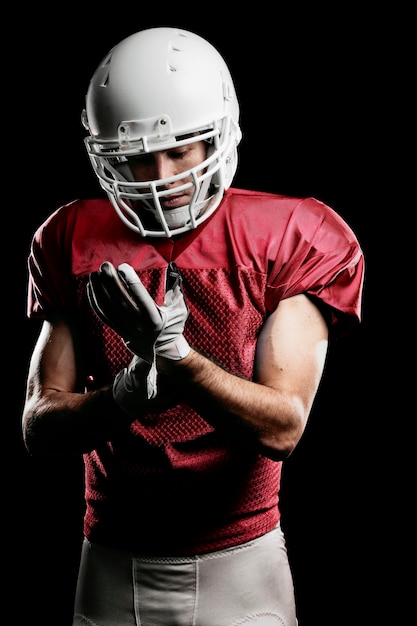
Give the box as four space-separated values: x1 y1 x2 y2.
156 295 328 460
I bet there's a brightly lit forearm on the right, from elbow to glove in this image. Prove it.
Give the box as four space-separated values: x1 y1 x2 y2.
158 350 308 460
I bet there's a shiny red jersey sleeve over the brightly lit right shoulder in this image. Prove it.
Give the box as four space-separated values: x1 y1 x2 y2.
268 198 364 334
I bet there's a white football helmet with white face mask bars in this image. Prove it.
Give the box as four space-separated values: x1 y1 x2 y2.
82 27 241 237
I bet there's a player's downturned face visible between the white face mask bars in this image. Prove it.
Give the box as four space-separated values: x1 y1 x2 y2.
124 141 207 210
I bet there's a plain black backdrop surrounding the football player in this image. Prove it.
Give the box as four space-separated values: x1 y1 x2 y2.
10 3 396 626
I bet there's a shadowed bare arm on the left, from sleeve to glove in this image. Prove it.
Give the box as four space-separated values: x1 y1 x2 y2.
22 319 146 455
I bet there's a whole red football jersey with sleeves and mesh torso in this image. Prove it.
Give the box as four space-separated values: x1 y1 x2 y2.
27 188 364 555
